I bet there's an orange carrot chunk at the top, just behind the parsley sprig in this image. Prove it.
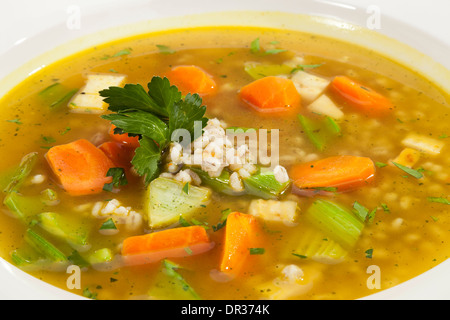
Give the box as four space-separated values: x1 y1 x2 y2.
166 66 216 96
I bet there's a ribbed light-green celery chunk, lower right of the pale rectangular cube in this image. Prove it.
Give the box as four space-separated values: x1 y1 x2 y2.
304 200 364 250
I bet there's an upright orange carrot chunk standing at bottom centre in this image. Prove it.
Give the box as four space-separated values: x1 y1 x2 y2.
220 212 263 278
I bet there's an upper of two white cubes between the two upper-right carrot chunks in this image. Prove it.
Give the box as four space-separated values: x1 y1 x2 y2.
291 70 330 104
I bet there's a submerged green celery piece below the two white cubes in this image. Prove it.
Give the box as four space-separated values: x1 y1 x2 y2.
298 114 341 151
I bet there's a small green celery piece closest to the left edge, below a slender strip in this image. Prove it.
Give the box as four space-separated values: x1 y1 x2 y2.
3 192 45 223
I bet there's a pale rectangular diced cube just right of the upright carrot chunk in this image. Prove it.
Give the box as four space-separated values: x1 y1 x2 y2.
248 199 298 225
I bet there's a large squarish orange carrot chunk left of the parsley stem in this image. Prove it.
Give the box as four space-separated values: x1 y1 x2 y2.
45 139 114 196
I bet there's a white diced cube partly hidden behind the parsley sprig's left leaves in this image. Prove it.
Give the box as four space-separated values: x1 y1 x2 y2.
68 73 127 113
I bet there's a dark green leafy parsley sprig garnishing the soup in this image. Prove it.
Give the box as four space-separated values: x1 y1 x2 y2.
100 77 208 184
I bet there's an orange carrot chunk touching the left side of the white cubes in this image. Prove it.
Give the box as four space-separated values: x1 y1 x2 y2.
239 76 301 115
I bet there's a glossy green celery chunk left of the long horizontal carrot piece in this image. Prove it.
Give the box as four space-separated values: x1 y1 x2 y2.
36 212 89 251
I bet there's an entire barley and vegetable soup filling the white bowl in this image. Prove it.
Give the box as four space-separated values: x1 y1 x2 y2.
0 28 450 299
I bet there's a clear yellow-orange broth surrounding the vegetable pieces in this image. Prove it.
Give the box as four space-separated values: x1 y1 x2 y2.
0 28 450 299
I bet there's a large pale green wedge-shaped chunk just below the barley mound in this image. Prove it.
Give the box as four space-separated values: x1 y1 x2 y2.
146 177 211 229
